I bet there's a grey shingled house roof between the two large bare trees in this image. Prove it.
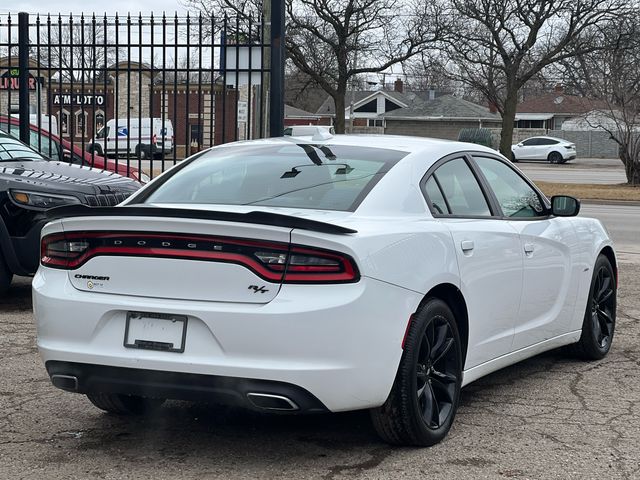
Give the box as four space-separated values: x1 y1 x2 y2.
384 95 501 122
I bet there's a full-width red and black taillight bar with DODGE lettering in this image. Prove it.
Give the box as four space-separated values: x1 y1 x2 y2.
40 232 360 283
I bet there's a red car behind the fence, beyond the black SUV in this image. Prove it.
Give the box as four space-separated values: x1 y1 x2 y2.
0 115 150 183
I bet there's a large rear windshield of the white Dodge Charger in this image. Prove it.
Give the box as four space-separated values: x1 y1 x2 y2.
141 144 406 211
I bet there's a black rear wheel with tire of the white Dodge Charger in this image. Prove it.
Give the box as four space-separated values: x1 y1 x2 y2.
371 298 462 447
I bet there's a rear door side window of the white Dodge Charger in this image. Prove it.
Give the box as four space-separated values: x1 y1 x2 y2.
425 158 491 217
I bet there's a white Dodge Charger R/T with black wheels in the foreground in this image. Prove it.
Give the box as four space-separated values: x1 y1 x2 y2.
33 135 617 445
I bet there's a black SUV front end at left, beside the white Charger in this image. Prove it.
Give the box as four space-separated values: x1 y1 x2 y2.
0 131 140 295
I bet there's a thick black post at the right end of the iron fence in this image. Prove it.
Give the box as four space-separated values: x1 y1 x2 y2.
269 0 285 137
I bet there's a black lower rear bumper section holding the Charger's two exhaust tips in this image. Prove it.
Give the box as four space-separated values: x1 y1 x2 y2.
46 361 327 413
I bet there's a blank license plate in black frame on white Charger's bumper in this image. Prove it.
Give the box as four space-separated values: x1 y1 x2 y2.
124 312 187 353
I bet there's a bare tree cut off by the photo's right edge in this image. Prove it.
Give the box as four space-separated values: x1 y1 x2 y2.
560 9 640 185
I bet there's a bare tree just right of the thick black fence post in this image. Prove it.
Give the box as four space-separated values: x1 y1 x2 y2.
185 0 446 133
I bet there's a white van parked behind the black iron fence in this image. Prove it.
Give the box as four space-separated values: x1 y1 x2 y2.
87 118 173 159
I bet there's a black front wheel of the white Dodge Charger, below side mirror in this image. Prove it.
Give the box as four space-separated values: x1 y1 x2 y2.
571 255 617 360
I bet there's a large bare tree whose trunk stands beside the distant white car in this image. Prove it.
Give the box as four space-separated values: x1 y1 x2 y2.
446 0 625 156
